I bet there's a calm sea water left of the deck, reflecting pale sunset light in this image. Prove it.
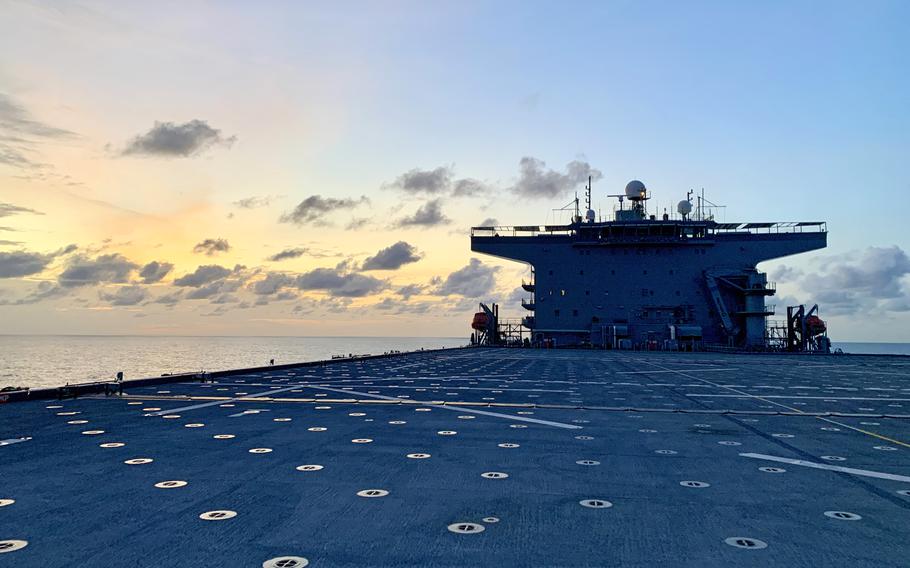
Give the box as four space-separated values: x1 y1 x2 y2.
0 335 466 388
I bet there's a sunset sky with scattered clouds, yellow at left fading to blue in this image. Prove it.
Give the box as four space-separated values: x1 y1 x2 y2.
0 0 910 342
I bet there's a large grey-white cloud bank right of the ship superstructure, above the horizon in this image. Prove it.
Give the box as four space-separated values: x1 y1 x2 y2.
778 246 910 315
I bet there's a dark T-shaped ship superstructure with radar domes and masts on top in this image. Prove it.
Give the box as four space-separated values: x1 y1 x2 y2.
471 180 827 349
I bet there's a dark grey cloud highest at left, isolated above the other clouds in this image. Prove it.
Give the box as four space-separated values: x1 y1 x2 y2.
121 119 237 158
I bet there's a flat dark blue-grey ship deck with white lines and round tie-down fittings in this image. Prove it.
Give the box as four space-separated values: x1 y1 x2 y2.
0 349 910 568
